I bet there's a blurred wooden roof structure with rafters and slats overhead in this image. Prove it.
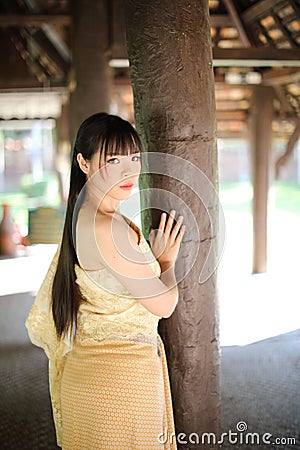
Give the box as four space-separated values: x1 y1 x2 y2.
0 0 300 137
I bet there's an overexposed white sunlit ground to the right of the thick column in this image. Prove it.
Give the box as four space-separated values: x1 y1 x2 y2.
219 211 300 345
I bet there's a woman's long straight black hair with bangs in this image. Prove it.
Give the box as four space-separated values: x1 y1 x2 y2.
52 113 142 337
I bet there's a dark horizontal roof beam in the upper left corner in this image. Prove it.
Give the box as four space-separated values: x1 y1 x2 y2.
0 14 72 27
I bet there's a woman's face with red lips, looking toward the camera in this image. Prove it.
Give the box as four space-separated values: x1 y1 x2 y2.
78 152 141 200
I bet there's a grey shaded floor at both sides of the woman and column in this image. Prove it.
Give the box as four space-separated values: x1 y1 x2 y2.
0 293 300 450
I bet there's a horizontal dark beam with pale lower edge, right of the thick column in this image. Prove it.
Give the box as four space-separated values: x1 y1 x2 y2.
213 47 300 67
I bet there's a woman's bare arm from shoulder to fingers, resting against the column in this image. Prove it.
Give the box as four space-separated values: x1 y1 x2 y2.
84 211 183 317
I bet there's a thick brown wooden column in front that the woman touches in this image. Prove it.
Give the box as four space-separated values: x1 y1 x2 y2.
125 0 219 450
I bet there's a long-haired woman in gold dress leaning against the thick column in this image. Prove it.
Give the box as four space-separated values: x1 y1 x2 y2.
26 113 184 450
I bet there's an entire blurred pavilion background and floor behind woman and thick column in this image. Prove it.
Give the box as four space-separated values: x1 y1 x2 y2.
0 0 300 450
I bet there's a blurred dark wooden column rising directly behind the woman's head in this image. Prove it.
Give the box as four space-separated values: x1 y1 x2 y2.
70 0 112 142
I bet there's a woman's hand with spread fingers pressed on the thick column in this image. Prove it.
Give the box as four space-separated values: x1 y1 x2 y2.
150 209 185 272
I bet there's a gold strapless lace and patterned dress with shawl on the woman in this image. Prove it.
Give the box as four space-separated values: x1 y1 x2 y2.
26 222 176 450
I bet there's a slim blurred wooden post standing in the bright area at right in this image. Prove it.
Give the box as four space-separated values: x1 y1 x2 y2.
250 86 274 273
